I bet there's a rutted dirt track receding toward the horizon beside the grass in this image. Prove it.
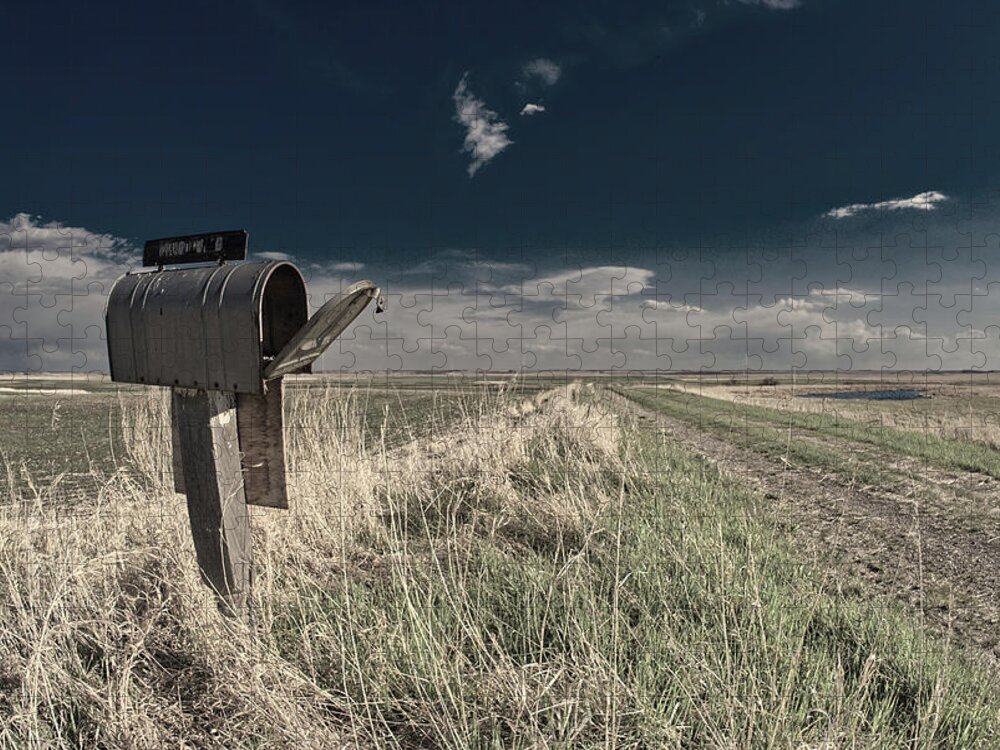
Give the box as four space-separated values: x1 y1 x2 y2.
614 395 1000 665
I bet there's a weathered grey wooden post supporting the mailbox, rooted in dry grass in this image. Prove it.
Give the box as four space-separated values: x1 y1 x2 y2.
171 388 251 617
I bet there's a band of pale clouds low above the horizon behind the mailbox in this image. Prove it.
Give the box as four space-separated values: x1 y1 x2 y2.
0 214 1000 374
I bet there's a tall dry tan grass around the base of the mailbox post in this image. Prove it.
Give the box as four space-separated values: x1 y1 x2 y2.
0 384 617 748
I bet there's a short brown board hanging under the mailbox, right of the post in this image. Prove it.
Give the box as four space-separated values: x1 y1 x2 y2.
236 378 288 509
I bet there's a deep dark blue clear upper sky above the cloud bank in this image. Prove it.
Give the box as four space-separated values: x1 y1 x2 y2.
7 0 1000 260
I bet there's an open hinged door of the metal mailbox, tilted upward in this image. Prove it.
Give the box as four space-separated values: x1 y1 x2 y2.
264 281 382 380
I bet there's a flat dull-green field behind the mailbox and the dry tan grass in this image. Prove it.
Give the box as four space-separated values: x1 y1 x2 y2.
0 375 547 501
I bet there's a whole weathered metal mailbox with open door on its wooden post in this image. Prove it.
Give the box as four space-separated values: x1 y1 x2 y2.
105 231 381 615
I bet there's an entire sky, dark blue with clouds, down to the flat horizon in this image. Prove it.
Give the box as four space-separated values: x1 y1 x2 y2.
9 0 1000 372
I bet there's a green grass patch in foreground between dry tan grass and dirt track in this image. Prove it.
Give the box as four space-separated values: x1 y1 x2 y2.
269 396 1000 748
